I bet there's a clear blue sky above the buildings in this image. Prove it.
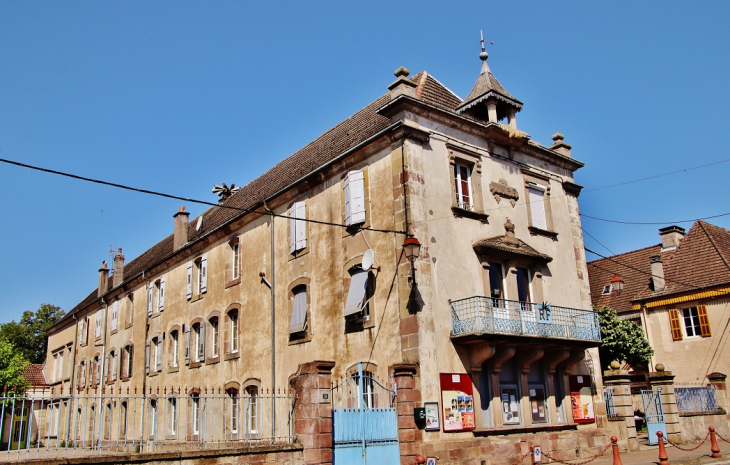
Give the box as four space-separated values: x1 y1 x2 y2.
0 1 730 322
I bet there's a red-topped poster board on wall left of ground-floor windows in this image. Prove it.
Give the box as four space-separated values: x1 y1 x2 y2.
440 373 475 431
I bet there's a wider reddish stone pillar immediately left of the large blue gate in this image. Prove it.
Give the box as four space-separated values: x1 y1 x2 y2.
289 360 335 464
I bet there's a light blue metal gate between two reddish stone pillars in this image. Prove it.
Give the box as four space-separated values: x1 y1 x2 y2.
332 363 400 465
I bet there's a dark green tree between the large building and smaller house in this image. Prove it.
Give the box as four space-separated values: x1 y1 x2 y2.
597 307 654 370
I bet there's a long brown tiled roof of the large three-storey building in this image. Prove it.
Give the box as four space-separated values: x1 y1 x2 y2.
57 71 461 324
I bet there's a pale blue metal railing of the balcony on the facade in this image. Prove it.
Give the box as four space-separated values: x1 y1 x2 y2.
451 296 601 345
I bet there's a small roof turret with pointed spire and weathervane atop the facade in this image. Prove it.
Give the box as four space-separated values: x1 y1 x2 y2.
456 31 522 129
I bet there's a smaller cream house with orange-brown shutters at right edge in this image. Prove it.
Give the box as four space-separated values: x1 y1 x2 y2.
588 221 730 386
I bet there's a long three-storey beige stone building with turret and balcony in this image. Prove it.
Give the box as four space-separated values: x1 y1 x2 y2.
46 49 602 456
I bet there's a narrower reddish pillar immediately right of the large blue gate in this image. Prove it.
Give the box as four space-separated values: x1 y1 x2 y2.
390 363 423 465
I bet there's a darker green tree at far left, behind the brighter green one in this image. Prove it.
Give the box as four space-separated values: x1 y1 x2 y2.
0 304 66 363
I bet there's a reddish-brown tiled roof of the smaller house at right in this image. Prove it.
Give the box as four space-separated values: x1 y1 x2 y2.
588 221 730 311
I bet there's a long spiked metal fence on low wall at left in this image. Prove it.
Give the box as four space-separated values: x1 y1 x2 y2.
0 388 294 461
